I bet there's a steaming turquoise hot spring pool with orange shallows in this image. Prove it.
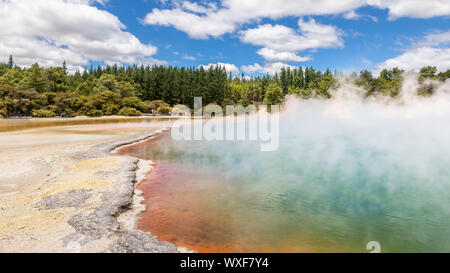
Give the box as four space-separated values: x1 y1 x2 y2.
121 101 450 252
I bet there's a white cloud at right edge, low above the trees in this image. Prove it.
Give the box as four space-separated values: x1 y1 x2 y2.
377 31 450 71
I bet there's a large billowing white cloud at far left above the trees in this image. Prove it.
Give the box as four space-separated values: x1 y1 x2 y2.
0 0 160 66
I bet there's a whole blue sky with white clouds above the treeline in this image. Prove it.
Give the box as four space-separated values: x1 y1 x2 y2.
0 0 450 75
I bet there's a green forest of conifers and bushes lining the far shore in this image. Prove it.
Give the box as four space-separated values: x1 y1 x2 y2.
0 56 450 118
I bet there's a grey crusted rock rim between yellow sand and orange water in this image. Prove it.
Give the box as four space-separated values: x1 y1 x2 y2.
64 131 185 253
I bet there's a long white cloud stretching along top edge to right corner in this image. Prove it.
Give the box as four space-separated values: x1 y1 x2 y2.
142 0 450 39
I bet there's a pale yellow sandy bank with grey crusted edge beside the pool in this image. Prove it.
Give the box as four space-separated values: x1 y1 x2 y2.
0 120 182 252
